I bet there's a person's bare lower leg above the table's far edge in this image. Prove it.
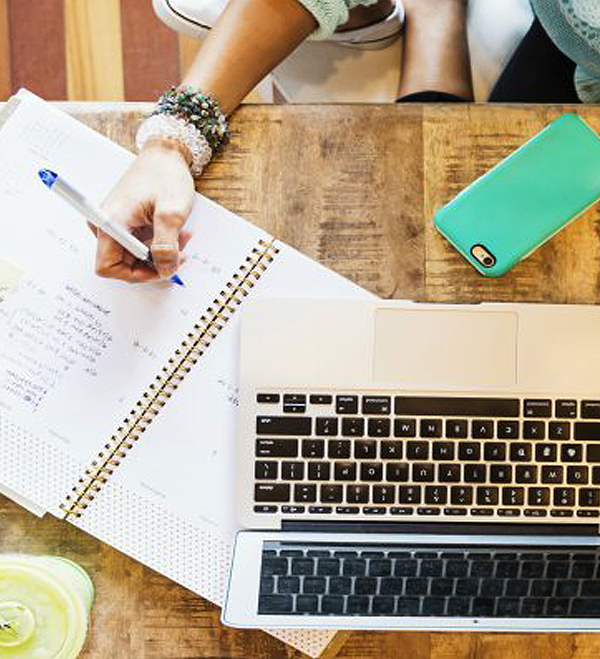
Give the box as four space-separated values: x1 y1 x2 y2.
398 0 473 101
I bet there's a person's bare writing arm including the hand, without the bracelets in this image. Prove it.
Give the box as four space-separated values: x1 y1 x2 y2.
96 0 317 282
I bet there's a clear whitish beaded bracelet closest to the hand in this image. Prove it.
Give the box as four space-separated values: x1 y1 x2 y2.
135 114 213 176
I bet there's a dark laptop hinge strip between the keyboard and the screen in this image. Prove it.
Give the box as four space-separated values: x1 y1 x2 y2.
281 519 600 537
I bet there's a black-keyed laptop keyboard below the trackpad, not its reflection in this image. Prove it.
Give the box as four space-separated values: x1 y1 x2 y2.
253 391 600 521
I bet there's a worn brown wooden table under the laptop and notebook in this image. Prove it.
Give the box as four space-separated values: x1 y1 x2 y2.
0 104 600 659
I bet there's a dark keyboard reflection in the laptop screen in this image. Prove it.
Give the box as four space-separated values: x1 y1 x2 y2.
258 542 600 618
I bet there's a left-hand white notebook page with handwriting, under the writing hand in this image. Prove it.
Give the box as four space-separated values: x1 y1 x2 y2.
0 97 266 510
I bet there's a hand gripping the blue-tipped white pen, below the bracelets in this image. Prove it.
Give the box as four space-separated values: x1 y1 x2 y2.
93 139 194 283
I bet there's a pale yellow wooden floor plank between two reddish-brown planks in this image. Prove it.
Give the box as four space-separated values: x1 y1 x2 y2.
65 0 125 101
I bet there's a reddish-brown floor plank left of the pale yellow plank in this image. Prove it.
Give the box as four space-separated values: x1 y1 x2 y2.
8 0 67 100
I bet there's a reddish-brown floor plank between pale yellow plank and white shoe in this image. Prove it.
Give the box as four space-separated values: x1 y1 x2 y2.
121 0 179 101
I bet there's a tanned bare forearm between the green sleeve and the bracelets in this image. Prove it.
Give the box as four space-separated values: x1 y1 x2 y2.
183 0 317 114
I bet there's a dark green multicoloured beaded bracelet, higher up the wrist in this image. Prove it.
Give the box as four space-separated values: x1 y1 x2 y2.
152 85 231 151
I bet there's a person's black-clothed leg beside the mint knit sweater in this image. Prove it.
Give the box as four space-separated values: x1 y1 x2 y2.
490 18 579 103
